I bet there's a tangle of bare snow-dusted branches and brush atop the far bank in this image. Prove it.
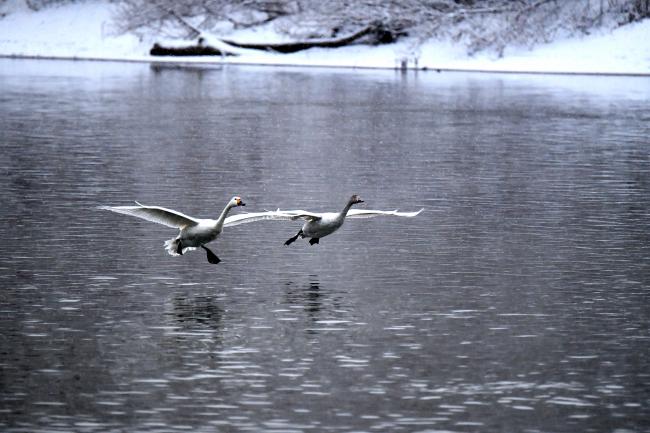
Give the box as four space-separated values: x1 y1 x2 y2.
111 0 650 55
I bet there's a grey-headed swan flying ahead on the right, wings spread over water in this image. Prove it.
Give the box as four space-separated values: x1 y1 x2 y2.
275 194 424 245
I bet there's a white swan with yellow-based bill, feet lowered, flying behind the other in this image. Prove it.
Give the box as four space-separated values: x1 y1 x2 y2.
99 196 287 265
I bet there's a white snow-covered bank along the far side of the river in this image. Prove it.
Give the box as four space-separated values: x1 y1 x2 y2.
0 0 650 75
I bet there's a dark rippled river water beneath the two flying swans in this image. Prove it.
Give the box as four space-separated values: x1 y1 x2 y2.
0 60 650 433
